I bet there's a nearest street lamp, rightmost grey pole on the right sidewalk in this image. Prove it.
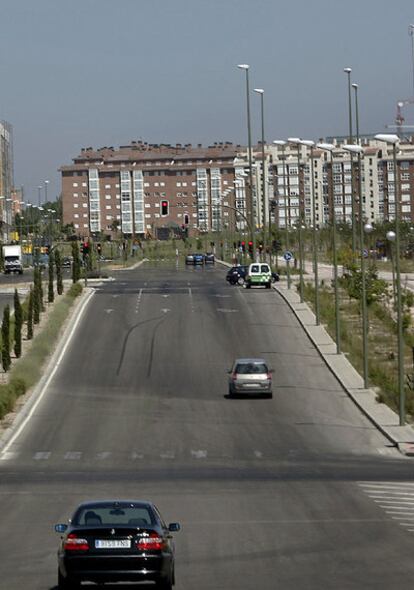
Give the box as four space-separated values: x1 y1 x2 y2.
375 133 405 426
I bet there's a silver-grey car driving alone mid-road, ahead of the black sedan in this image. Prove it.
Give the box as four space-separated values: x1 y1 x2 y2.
229 358 273 397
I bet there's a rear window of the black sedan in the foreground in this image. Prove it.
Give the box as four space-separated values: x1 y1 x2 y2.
73 504 155 526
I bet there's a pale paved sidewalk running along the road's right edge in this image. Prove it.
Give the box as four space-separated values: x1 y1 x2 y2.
217 260 414 456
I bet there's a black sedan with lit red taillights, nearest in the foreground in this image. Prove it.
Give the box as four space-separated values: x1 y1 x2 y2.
55 500 180 590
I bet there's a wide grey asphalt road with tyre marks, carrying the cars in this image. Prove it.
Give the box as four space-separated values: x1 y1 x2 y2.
0 263 414 590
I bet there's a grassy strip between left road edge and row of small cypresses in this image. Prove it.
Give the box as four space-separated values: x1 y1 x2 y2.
0 283 82 419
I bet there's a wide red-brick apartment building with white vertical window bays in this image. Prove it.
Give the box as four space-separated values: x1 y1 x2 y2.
60 141 252 237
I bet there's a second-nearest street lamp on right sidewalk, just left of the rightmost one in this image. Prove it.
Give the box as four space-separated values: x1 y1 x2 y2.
342 145 369 389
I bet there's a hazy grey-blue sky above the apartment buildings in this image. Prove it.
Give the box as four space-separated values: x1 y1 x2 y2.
0 0 414 203
